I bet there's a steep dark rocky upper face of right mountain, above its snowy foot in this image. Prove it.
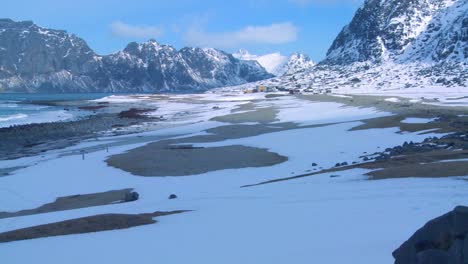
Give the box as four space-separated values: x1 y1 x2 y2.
324 0 468 65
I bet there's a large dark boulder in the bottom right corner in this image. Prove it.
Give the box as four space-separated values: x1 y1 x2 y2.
393 206 468 264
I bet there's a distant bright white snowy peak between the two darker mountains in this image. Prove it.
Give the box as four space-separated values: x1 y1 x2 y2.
233 49 315 76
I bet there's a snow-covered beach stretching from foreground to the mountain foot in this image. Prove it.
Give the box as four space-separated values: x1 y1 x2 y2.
0 94 468 263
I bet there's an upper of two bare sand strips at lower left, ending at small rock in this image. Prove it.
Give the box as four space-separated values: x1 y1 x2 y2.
0 189 138 219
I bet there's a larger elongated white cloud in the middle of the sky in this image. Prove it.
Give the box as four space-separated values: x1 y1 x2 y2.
184 22 299 48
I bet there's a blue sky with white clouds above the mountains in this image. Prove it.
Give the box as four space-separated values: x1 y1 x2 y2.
0 0 363 61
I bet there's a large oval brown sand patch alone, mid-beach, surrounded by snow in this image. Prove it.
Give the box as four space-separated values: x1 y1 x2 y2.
107 144 287 177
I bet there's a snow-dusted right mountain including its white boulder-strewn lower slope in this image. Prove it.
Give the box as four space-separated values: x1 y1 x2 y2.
225 0 468 94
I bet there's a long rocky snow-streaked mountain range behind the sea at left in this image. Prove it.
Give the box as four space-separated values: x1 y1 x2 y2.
0 19 273 92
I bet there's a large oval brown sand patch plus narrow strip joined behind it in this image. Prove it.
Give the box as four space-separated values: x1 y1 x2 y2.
106 119 336 176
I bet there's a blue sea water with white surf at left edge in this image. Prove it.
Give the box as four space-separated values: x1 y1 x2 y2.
0 93 111 127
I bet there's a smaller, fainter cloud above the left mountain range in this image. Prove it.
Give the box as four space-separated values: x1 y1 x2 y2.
111 21 163 39
